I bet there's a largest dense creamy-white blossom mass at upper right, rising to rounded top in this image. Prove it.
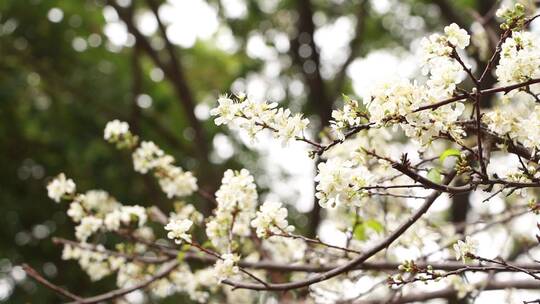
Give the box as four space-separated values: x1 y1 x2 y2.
346 24 470 145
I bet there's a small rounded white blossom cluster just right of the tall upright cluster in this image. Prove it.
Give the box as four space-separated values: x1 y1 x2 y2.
251 202 294 238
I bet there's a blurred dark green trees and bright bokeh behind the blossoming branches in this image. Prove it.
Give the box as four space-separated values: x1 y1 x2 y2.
0 0 506 303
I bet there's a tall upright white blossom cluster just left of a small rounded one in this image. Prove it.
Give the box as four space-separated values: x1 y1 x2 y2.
206 169 257 248
